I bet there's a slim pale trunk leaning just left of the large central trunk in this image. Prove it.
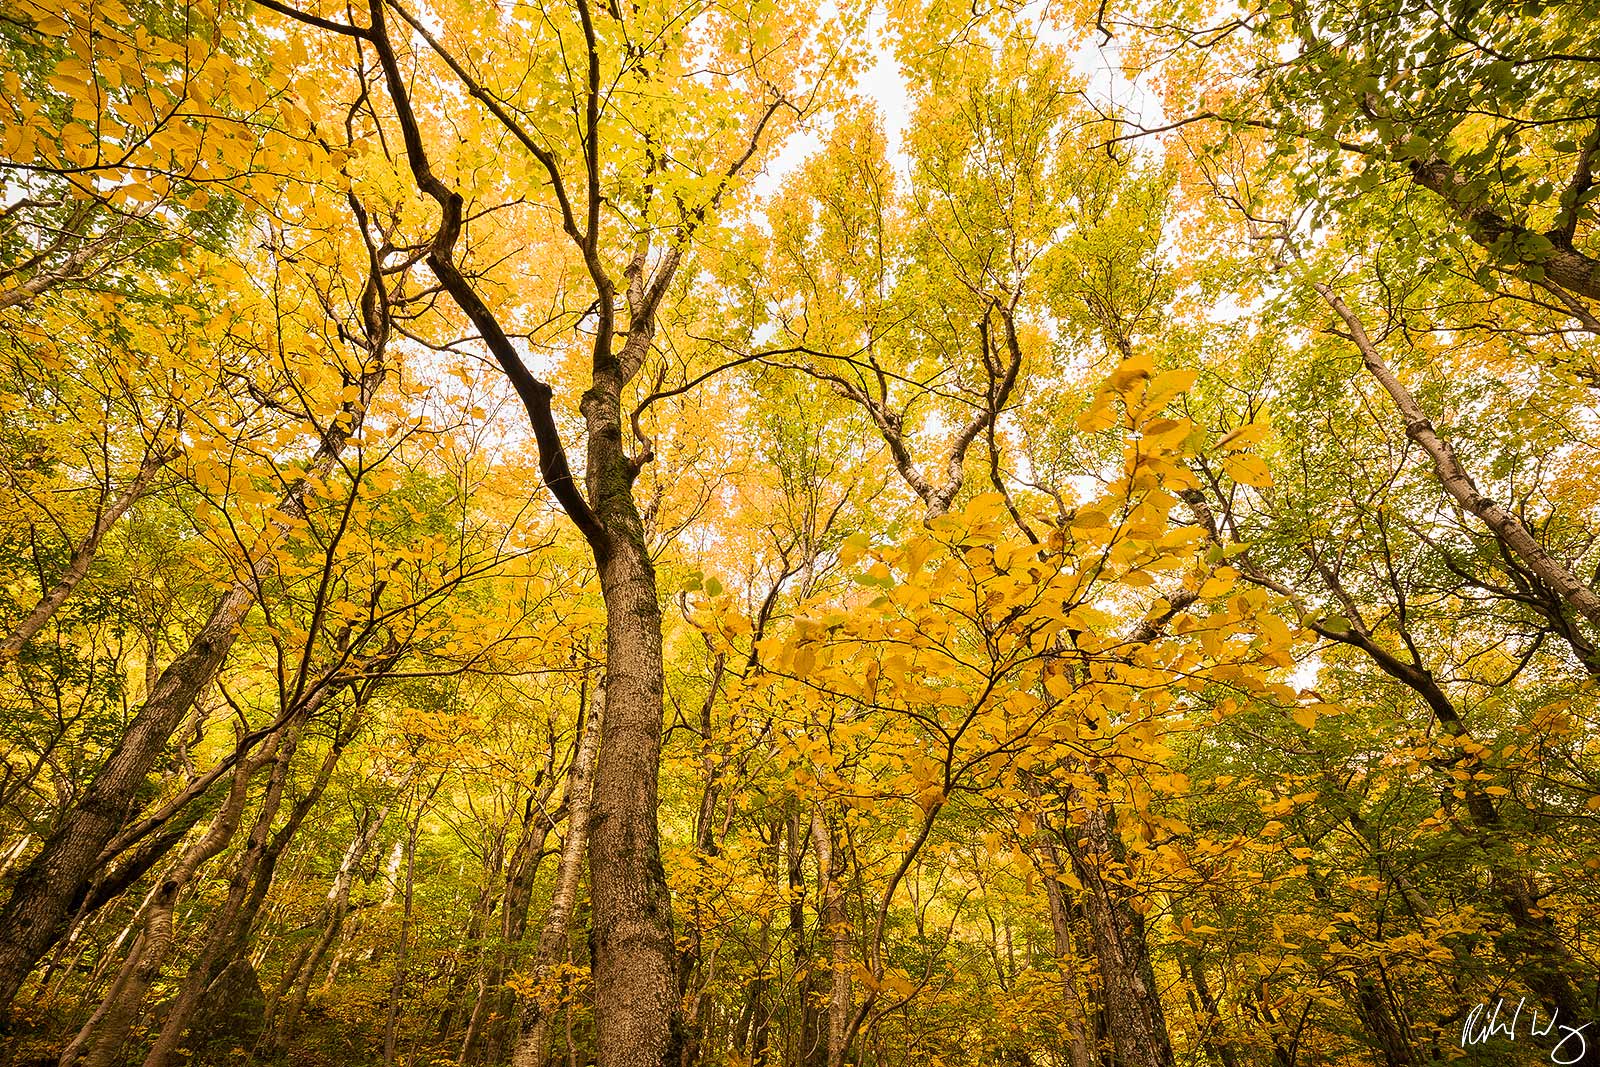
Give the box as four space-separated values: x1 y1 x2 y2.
512 686 604 1067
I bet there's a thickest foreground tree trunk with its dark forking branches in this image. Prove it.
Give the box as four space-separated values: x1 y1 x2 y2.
336 8 700 1067
